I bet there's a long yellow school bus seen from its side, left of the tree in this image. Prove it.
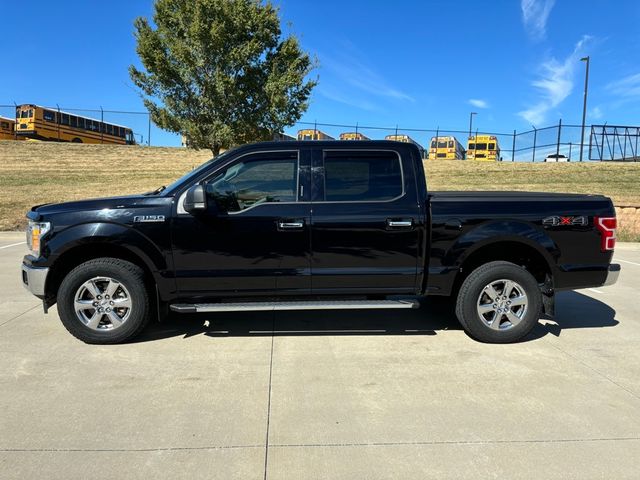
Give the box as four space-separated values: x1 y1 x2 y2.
16 105 136 145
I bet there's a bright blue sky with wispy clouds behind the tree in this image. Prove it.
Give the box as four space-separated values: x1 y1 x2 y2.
0 0 640 145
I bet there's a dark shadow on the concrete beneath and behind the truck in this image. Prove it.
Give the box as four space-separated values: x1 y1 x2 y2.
133 292 619 343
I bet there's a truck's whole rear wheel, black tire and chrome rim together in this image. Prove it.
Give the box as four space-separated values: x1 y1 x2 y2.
456 261 542 343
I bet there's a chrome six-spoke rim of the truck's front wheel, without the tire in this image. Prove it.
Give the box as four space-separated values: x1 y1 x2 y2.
73 277 131 331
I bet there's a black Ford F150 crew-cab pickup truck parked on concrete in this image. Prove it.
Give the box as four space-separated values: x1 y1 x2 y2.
22 141 620 343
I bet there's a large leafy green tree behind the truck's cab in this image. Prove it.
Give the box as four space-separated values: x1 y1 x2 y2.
129 0 317 155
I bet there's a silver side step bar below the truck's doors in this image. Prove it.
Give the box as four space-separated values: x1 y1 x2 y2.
170 300 420 313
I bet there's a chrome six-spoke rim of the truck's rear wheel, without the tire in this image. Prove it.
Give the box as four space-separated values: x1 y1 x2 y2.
477 279 529 330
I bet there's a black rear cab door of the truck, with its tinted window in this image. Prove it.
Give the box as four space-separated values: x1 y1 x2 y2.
311 147 423 294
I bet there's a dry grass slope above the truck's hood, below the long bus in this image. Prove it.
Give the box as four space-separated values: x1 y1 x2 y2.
0 141 211 230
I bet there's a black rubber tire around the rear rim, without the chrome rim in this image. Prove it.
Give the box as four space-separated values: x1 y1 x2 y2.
456 261 542 343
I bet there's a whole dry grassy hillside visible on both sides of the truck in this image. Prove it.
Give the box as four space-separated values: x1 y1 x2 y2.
0 141 640 240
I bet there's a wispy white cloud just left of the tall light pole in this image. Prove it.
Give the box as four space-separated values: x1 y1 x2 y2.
518 35 591 125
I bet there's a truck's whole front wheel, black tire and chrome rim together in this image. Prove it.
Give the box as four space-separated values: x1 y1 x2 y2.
57 258 149 344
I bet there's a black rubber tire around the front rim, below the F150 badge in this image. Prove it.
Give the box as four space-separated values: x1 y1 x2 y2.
57 257 150 344
